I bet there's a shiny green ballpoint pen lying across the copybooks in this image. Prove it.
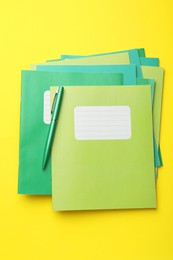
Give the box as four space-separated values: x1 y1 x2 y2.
42 87 64 169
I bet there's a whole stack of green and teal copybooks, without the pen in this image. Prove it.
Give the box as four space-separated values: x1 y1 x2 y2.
18 49 164 210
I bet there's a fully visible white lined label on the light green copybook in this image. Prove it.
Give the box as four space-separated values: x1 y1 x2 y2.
74 106 131 140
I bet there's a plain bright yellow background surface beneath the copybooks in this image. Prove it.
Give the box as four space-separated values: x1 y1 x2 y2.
0 0 173 260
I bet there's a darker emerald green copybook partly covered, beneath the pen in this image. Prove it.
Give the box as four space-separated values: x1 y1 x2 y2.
18 71 123 195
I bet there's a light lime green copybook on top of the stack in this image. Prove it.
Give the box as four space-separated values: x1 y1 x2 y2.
51 86 156 211
